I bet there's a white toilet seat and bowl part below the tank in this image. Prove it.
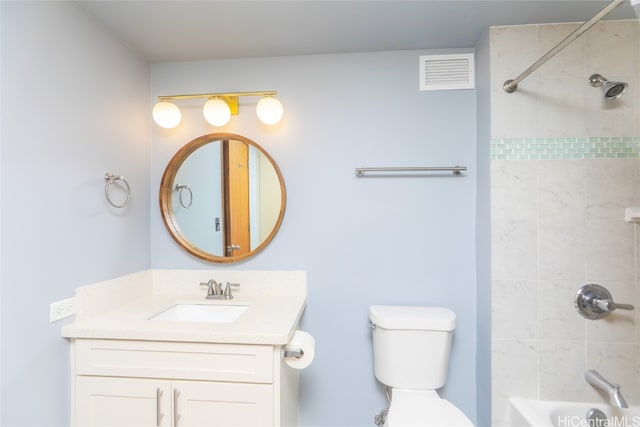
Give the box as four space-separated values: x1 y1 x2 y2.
385 388 473 427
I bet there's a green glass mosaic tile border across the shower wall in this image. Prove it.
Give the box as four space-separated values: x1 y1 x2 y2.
490 136 640 160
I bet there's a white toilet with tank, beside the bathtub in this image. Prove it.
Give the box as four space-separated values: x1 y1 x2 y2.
369 305 473 427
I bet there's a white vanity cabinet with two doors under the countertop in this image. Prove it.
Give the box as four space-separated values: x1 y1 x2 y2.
71 339 298 427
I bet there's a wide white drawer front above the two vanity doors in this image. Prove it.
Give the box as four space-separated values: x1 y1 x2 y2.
75 339 274 383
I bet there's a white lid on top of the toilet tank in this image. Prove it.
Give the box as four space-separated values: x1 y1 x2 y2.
369 305 456 331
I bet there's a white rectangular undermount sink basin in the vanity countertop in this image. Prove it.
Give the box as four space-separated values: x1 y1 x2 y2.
149 304 248 323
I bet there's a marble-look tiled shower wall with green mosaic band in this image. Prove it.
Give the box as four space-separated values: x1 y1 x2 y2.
490 21 640 426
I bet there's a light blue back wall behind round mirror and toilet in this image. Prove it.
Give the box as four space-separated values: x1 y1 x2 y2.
151 51 480 427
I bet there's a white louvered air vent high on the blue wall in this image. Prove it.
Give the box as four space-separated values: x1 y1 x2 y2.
420 53 475 90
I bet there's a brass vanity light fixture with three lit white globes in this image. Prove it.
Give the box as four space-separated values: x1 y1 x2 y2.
153 91 283 129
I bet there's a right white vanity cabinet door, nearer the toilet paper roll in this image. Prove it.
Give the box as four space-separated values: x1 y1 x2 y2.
172 381 274 427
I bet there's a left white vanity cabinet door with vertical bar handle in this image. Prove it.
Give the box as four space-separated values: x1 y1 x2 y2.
75 376 172 427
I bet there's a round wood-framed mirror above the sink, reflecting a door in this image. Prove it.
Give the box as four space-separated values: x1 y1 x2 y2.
160 133 286 262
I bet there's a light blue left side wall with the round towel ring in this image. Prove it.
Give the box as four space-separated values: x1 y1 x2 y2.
0 1 151 427
